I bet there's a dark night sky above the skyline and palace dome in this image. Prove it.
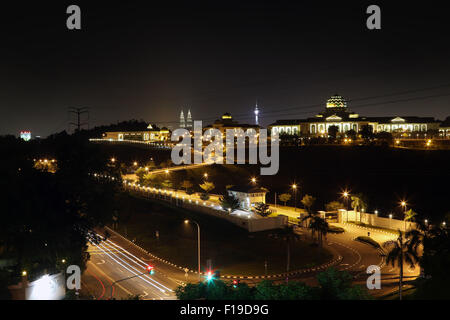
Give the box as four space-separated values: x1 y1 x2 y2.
0 0 450 136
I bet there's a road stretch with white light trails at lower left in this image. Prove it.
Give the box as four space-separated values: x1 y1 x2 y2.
82 235 192 300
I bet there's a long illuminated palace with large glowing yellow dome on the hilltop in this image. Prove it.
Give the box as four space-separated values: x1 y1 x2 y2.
269 94 450 138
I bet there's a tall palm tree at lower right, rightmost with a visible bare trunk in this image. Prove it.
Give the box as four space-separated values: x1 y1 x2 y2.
383 230 419 300
